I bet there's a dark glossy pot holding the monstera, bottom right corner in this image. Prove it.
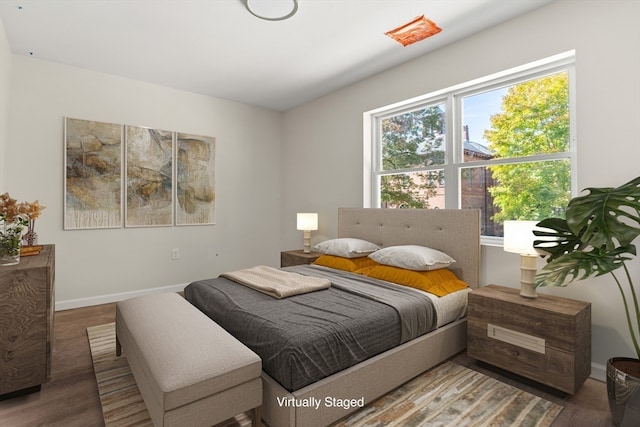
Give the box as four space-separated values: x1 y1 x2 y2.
607 357 640 427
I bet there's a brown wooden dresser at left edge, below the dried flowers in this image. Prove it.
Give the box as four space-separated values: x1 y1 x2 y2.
0 245 55 395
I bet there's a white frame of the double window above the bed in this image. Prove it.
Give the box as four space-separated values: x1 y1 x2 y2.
363 50 578 246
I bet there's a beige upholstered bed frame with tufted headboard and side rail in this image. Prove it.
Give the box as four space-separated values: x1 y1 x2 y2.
262 209 480 427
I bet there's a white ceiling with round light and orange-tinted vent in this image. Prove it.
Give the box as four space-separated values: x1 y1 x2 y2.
0 0 552 111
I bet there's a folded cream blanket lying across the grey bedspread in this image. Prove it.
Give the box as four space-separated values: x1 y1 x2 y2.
220 265 331 298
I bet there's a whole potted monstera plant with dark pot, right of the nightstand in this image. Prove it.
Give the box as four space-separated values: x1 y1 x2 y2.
534 177 640 425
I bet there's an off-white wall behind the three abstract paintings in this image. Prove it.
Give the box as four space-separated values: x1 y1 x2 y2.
2 55 282 309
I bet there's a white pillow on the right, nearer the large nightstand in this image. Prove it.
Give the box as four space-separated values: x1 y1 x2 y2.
369 245 456 271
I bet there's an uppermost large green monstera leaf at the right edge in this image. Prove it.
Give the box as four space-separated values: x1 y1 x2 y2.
567 177 640 250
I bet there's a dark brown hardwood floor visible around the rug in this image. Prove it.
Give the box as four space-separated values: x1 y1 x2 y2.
0 304 613 427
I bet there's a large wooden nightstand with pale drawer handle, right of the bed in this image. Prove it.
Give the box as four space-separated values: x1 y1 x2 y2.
467 285 591 394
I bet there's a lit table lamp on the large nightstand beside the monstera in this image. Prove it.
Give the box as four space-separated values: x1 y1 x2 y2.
504 221 538 298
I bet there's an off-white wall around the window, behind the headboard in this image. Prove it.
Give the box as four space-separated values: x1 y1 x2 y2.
283 0 640 378
